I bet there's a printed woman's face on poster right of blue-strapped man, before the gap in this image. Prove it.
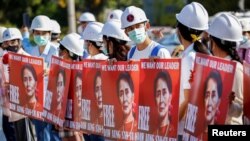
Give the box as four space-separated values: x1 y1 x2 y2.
155 78 171 118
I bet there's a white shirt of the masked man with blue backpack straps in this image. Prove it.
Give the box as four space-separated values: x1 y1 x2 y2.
128 41 171 60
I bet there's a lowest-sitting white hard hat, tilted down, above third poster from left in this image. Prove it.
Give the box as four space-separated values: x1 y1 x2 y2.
60 33 84 56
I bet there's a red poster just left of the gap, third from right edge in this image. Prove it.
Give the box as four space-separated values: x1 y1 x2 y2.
138 59 181 141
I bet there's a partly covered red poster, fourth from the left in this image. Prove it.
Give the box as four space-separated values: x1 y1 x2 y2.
82 60 103 135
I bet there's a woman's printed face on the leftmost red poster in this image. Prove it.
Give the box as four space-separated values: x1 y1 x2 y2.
23 68 37 96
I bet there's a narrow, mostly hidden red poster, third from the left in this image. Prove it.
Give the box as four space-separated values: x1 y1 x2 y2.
64 62 83 131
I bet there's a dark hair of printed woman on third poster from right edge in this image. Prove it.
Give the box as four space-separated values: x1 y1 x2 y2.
154 71 172 95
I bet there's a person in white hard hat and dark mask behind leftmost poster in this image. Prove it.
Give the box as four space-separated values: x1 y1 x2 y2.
2 28 36 141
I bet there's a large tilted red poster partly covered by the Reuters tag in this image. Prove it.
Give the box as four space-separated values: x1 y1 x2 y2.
183 53 236 141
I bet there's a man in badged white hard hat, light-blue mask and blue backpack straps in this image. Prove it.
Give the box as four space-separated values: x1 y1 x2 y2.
121 6 171 60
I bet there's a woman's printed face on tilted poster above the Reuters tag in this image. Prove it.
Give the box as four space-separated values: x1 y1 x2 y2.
205 79 220 123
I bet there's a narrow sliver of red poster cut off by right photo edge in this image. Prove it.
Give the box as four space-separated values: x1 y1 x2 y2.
243 61 250 125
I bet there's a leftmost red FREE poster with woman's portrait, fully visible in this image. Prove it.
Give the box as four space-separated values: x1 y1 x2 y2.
9 53 44 119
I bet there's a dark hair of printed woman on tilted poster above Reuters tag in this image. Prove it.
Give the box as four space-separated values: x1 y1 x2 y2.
203 70 223 98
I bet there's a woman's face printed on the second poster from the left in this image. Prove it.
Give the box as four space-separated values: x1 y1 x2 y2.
56 73 64 103
